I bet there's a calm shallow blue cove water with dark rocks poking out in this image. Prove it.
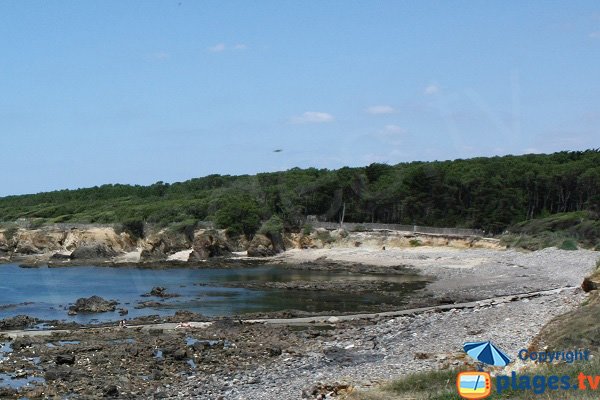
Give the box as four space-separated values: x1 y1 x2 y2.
0 264 425 323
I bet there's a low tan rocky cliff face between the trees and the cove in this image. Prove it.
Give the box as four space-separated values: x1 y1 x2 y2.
0 226 501 264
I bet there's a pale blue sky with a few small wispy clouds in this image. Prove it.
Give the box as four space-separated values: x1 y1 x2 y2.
0 0 600 196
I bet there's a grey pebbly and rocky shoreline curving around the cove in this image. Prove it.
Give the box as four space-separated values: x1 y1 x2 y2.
0 246 599 400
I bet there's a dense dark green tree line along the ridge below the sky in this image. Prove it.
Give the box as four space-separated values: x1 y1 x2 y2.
0 149 600 235
